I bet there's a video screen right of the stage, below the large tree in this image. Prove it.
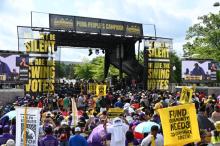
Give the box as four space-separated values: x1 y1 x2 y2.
182 60 218 82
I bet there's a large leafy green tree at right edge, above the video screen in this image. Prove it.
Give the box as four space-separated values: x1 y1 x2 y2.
183 11 220 61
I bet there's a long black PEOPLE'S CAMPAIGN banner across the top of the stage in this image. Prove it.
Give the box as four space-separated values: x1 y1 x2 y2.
49 14 143 37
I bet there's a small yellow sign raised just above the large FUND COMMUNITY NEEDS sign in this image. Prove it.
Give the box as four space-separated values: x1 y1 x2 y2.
180 86 193 104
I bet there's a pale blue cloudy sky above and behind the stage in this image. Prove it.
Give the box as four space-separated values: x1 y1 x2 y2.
0 0 220 62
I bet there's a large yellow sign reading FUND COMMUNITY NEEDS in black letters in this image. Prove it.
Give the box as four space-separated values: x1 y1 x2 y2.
158 104 200 146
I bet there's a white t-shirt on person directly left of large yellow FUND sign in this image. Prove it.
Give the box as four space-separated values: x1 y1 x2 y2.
141 134 164 146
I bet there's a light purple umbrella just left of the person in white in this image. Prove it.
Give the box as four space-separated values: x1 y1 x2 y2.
87 123 110 143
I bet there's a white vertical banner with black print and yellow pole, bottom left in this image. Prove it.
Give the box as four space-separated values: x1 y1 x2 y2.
16 107 41 146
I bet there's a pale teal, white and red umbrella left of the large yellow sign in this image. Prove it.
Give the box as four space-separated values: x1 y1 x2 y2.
134 121 160 139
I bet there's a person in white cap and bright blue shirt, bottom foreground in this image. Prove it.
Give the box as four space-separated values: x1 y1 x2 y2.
69 127 88 146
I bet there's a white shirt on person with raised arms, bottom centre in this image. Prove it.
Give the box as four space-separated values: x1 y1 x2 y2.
107 123 129 146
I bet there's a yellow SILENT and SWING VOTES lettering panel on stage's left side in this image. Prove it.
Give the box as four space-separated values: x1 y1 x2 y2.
25 33 56 93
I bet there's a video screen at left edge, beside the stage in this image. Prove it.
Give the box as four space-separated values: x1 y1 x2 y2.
0 53 29 82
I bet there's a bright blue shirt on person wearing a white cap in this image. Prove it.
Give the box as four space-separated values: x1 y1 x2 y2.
69 134 88 146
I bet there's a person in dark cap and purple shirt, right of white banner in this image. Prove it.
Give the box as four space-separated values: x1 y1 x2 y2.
38 125 59 146
